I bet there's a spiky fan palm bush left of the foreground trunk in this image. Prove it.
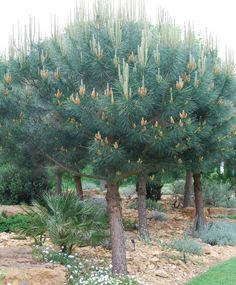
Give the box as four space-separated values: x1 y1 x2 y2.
18 193 108 252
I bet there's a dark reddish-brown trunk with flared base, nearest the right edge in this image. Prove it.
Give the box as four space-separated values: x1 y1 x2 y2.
193 173 206 233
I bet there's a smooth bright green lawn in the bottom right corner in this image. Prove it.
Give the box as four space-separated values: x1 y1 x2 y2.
185 257 236 285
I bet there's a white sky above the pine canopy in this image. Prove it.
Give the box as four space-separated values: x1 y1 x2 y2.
0 0 236 58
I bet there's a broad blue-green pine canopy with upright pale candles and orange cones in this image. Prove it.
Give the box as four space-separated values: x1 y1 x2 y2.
0 1 236 181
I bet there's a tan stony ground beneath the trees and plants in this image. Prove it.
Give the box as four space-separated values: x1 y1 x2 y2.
0 192 236 285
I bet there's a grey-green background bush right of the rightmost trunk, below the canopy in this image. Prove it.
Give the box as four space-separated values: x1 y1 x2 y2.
202 180 233 207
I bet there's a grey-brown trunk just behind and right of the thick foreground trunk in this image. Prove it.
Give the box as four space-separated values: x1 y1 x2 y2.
138 177 149 240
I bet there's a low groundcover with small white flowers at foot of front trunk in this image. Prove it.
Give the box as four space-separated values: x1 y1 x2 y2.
33 247 140 285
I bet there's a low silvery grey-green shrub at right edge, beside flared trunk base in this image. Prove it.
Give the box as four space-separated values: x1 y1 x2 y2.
200 221 236 245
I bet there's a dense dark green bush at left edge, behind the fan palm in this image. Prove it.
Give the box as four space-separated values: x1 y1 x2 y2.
0 163 48 205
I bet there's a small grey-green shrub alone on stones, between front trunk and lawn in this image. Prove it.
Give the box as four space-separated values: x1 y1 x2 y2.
170 237 202 263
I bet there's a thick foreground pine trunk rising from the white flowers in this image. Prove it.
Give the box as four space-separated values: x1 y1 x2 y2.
106 182 127 274
